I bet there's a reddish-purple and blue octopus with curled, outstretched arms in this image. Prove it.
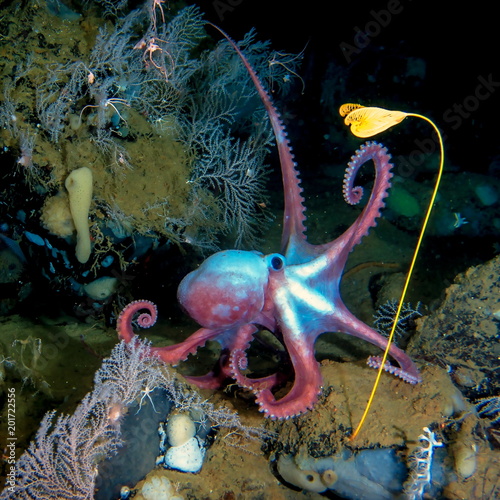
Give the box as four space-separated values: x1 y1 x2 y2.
117 26 421 418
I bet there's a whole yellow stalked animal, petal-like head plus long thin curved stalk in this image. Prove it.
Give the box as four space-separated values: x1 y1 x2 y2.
339 103 444 439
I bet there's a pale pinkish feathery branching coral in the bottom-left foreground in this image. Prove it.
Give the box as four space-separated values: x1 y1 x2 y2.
0 340 265 500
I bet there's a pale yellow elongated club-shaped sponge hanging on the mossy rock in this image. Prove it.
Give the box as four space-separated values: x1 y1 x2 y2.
65 167 92 264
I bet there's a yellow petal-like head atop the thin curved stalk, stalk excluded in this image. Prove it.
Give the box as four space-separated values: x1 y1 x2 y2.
339 103 409 138
